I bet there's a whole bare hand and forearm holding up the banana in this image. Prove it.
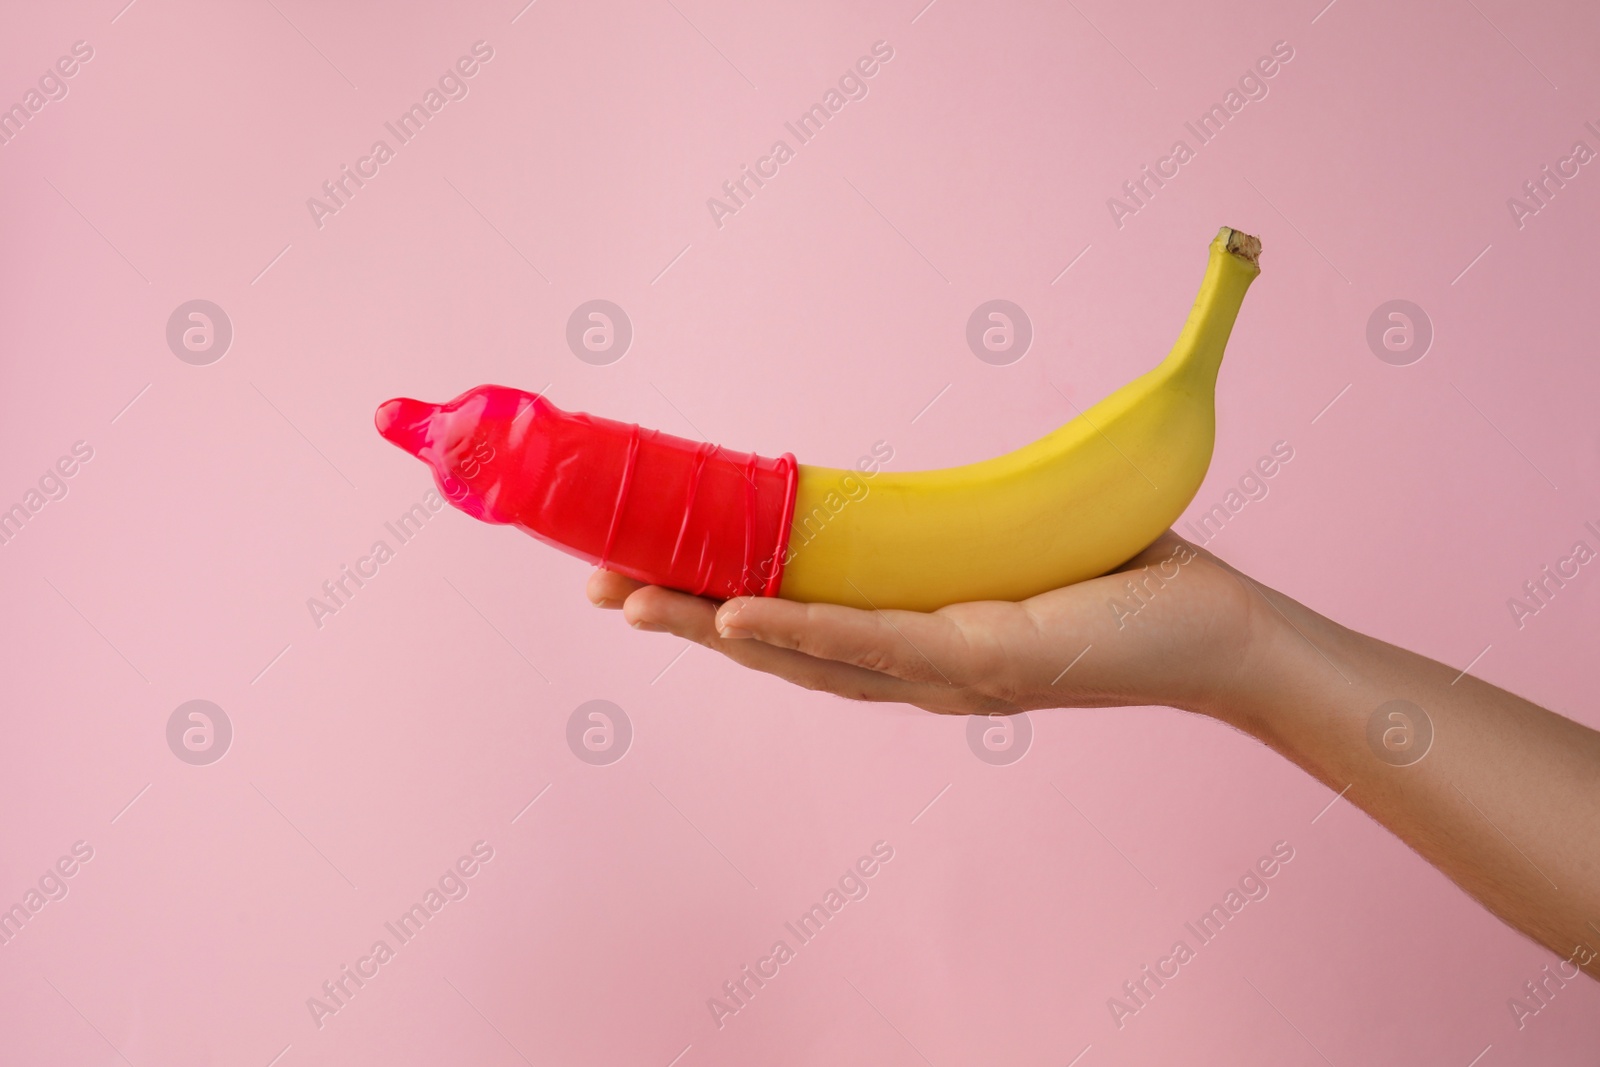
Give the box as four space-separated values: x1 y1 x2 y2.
587 533 1600 979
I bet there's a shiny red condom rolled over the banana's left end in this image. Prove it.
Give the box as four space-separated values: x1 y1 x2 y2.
374 386 795 598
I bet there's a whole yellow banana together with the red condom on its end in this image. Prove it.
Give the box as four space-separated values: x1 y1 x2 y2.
374 227 1261 611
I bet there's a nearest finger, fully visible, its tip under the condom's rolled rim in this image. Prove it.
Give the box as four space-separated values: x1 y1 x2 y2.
717 597 966 686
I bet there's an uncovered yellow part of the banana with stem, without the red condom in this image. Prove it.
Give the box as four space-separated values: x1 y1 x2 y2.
781 227 1261 611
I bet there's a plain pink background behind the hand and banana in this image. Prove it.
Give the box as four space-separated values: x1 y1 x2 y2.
0 0 1600 1067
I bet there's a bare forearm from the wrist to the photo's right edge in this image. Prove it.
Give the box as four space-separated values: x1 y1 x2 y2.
1197 590 1600 977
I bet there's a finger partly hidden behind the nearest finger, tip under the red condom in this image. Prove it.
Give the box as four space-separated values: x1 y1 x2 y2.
622 585 957 710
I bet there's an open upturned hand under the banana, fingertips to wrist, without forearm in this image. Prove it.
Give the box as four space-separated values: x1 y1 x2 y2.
587 531 1272 713
